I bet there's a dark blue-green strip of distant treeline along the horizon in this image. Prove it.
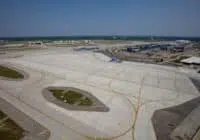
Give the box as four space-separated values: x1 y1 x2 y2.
0 36 200 42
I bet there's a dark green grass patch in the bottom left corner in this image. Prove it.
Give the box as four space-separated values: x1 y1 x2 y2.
0 111 24 140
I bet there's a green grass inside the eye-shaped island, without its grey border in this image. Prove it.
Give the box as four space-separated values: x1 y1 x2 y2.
50 89 93 106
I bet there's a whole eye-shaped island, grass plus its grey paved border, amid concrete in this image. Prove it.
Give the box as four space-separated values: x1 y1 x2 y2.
43 87 109 112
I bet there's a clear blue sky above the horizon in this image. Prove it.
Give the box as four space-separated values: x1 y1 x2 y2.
0 0 200 37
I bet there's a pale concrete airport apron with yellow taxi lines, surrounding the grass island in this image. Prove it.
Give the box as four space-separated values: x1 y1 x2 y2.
0 48 199 140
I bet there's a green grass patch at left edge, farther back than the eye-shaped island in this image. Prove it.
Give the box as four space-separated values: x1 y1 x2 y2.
0 65 24 79
